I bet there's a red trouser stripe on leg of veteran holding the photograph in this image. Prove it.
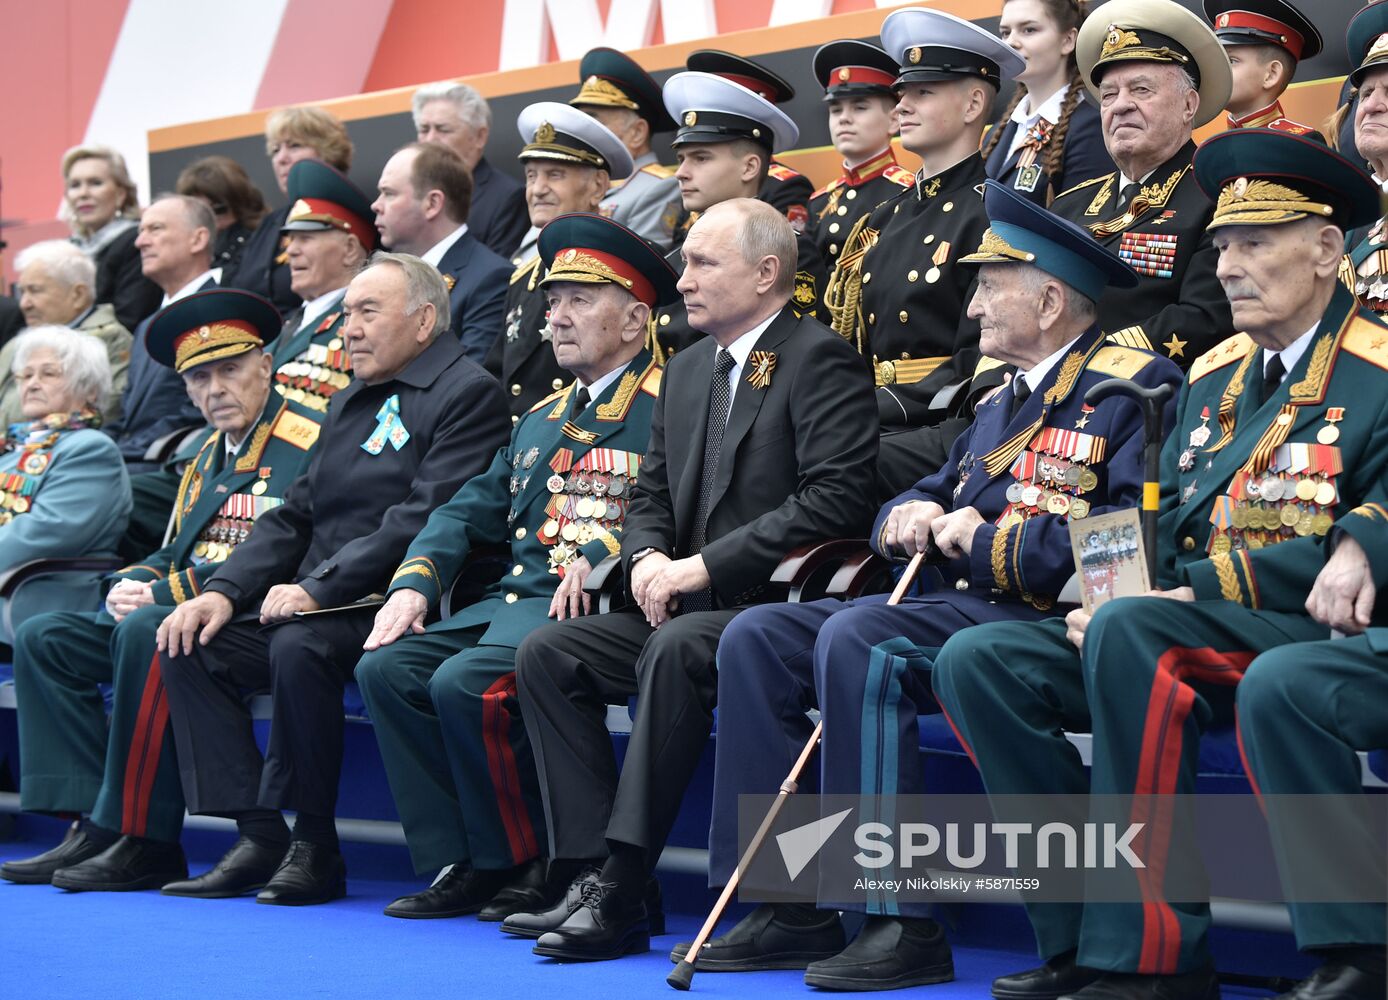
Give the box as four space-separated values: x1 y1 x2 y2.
1133 646 1255 975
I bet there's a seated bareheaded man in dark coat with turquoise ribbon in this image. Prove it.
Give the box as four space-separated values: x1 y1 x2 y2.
158 253 508 906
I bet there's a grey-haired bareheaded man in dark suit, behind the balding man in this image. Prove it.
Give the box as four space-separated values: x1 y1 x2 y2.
411 81 530 257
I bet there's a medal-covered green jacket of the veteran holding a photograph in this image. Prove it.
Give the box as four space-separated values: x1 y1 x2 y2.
1158 286 1388 611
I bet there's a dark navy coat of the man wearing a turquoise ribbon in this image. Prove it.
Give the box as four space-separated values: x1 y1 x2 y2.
207 336 511 611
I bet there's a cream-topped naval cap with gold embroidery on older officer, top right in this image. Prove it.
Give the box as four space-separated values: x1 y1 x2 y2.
1074 0 1234 128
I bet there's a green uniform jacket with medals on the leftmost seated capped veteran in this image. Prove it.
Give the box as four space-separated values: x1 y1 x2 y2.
114 392 321 606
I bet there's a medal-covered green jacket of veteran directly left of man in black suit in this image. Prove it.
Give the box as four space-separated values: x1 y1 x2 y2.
390 351 661 647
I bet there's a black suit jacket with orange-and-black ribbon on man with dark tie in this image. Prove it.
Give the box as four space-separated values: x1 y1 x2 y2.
622 308 877 607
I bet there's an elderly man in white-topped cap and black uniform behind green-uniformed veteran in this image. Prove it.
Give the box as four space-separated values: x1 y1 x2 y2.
483 101 632 424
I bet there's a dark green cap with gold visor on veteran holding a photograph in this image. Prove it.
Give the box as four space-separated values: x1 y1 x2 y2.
1194 128 1380 232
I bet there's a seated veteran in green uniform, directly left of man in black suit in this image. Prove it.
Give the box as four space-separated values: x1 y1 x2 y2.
357 215 677 921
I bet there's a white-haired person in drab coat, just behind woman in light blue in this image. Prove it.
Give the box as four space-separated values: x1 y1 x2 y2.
8 240 130 426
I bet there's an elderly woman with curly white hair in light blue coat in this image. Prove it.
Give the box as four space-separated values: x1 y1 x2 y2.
0 326 130 643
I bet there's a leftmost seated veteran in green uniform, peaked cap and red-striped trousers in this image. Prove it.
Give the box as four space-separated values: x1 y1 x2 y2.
0 289 318 890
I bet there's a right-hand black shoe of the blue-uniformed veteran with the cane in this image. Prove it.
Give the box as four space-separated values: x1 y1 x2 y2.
805 917 954 990
